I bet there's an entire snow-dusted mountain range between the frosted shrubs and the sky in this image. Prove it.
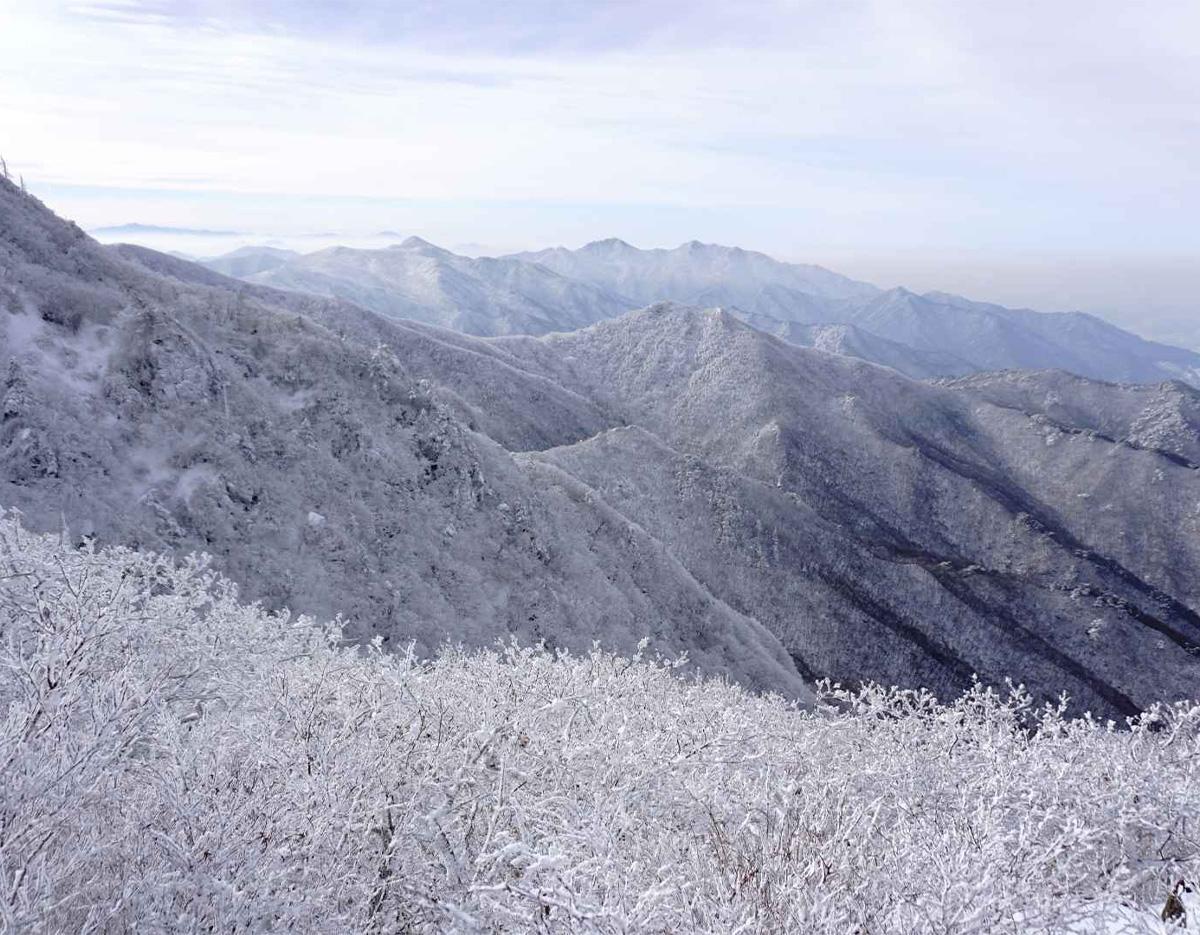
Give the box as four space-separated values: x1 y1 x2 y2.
7 182 1200 717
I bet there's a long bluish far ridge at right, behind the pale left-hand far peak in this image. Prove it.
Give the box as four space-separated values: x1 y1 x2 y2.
516 240 1200 385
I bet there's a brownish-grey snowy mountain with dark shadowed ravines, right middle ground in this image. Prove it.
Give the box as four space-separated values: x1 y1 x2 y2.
482 306 1200 712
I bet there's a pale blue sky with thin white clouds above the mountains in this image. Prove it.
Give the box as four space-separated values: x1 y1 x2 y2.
0 0 1200 346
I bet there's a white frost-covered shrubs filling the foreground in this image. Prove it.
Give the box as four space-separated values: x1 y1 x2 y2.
0 519 1200 933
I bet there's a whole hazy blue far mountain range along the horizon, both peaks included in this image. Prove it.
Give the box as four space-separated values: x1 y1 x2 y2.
201 238 1200 385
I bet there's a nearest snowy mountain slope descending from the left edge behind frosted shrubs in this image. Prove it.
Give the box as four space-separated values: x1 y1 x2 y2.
0 182 804 695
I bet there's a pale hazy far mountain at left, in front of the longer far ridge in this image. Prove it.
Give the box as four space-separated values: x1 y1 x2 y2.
226 238 636 335
